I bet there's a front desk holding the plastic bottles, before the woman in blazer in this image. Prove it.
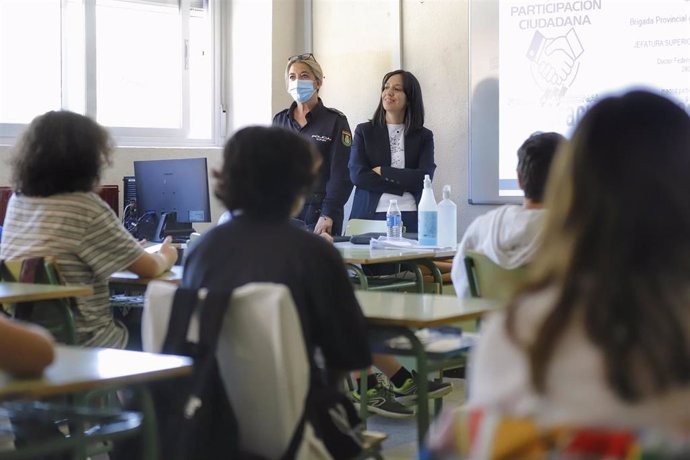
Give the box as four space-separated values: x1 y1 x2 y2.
335 242 455 294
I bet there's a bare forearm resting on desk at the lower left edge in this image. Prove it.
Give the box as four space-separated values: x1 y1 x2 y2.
0 316 55 375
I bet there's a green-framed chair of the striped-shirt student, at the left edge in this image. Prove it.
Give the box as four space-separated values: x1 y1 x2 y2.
0 257 77 345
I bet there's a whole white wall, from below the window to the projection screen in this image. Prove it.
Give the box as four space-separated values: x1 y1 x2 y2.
0 0 491 235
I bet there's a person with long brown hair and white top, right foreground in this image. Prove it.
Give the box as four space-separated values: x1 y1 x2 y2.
470 91 690 439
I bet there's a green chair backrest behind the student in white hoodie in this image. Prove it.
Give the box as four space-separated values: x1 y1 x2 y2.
465 250 528 302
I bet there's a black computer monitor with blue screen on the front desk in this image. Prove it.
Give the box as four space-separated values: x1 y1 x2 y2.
134 158 211 241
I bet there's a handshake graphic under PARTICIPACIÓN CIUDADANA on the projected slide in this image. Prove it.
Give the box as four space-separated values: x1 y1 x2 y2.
527 29 584 91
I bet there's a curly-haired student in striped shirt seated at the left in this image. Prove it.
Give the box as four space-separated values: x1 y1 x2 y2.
0 111 177 348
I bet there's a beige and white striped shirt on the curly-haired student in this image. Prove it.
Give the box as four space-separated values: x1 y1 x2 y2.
0 192 145 348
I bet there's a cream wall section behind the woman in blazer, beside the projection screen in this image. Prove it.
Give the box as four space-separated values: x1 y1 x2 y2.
313 0 492 236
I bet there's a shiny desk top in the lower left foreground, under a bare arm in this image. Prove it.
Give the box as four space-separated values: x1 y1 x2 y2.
0 345 192 400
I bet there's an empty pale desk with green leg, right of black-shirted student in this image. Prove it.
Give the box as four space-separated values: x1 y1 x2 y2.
356 291 503 446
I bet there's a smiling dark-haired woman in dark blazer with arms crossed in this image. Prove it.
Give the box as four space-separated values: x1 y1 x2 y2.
349 70 436 232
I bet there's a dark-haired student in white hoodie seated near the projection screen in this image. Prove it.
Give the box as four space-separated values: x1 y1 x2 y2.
451 133 565 297
